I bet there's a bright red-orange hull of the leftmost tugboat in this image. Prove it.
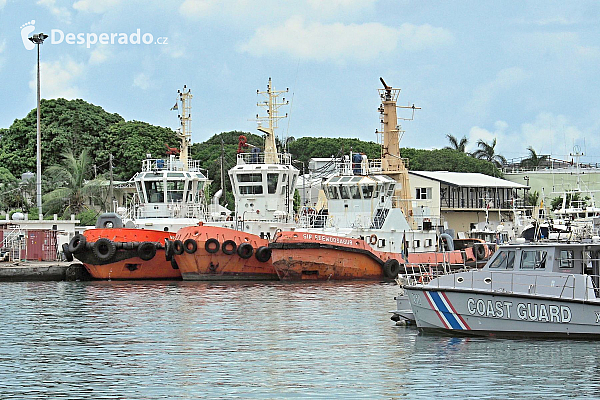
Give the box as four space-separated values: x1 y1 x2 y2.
74 228 181 280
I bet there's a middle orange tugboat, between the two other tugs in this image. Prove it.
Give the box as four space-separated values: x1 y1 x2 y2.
171 78 299 280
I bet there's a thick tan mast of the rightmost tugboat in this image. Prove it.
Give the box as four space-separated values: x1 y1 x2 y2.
376 78 420 228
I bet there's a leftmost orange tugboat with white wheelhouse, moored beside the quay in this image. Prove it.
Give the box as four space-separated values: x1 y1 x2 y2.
66 87 209 280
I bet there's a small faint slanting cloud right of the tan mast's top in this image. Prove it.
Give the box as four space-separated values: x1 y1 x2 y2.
466 67 527 116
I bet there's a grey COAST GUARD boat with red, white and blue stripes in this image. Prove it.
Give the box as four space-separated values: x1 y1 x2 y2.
404 240 600 339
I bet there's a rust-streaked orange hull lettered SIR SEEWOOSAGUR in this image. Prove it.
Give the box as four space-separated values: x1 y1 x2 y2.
269 232 482 280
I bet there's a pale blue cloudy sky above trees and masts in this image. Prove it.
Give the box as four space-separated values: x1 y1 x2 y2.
0 0 600 163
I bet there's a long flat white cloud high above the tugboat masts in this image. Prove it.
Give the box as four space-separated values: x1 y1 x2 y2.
239 16 453 61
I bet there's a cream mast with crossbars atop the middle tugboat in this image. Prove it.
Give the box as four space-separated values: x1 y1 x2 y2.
256 78 289 164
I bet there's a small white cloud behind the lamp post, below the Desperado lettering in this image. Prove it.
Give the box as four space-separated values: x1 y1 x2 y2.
29 58 85 99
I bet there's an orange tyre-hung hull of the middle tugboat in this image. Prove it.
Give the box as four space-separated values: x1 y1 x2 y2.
174 225 279 280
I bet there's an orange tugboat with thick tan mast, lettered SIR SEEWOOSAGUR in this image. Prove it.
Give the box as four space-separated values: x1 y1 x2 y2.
269 79 490 280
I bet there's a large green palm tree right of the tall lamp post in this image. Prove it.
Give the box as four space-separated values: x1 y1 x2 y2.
44 149 104 215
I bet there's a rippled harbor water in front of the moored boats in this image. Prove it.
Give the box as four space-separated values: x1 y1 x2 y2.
0 281 600 399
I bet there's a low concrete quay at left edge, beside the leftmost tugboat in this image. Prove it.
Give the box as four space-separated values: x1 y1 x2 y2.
0 261 91 282
